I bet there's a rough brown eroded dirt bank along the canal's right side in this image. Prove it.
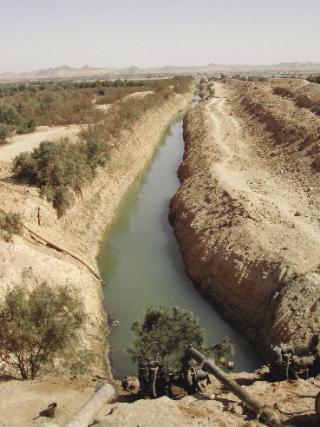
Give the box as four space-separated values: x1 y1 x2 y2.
170 81 320 352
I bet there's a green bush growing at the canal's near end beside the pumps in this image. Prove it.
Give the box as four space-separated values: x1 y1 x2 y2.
128 306 233 368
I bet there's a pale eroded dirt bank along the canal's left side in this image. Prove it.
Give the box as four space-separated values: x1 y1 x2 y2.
0 89 192 376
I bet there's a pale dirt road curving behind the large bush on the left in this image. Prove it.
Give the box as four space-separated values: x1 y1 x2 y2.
0 125 81 162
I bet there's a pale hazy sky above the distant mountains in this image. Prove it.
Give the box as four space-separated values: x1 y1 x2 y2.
0 0 320 72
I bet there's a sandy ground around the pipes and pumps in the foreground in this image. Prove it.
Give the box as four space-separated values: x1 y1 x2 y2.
0 372 320 427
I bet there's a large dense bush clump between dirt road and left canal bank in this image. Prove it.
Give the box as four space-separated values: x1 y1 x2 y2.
13 137 108 217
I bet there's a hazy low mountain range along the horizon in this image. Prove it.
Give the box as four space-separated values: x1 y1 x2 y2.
0 62 320 82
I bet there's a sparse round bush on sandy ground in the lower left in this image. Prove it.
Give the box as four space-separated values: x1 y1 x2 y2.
0 283 85 379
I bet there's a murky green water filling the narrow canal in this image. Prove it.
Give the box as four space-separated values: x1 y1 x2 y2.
98 117 258 378
